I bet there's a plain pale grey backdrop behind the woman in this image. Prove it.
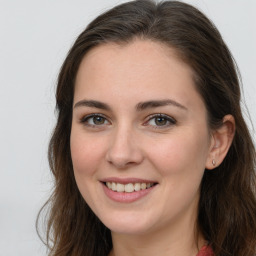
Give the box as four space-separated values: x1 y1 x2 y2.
0 0 256 256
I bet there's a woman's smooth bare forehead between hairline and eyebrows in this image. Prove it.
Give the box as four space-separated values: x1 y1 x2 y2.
74 40 204 111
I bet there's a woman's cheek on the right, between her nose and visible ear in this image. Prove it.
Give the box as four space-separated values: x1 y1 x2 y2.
148 130 208 175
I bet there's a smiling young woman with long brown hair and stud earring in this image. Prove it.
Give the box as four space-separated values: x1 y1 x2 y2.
37 0 256 256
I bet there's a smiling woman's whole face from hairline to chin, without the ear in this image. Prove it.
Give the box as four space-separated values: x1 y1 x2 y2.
71 40 212 234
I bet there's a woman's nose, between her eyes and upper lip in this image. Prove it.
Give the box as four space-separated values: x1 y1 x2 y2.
106 127 143 169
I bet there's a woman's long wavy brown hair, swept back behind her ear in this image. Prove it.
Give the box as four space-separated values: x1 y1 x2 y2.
37 0 256 256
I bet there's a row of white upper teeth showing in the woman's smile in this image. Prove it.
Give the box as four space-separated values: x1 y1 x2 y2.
106 182 154 193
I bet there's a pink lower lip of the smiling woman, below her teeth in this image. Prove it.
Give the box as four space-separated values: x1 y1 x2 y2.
102 183 156 203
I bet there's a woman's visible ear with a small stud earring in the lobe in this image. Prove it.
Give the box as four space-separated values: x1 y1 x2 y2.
205 115 235 170
